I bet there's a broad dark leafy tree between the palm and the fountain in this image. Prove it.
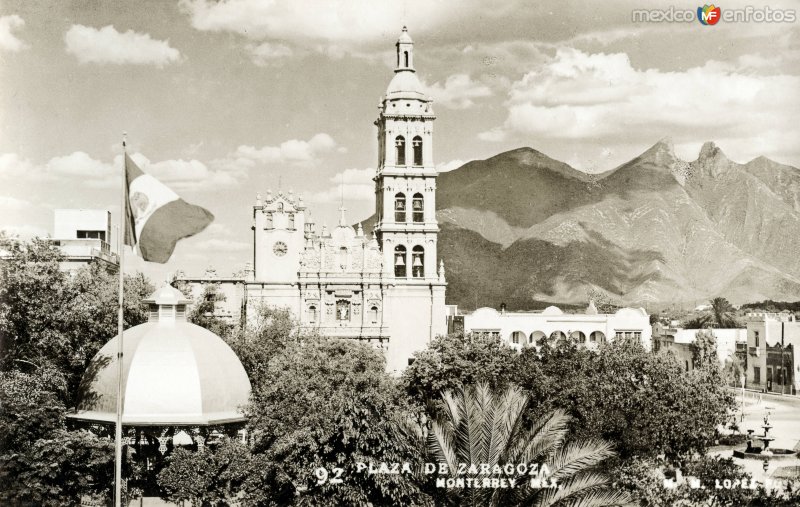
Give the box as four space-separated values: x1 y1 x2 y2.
517 342 734 459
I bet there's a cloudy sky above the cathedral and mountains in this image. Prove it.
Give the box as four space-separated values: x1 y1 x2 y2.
0 0 800 280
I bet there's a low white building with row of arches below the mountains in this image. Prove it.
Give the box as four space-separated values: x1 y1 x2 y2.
463 304 652 350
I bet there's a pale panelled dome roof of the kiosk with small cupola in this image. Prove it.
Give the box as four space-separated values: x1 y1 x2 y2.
71 286 250 426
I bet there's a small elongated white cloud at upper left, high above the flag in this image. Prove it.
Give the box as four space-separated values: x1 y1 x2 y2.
64 25 180 68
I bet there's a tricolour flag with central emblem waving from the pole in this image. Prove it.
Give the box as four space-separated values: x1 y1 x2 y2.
125 153 214 264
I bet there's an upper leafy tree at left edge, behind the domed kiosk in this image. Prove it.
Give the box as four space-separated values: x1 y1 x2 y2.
0 235 153 406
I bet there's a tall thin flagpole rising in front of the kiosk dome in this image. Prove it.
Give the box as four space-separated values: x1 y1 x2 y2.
114 132 128 507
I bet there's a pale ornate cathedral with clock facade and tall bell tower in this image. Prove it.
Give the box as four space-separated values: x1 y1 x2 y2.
184 27 447 372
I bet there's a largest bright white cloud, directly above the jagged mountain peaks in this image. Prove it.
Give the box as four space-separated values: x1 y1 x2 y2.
479 48 800 158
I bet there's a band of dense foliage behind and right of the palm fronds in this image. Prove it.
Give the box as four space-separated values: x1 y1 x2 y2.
404 338 733 458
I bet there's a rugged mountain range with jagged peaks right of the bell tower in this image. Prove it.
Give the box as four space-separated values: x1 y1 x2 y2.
400 140 800 310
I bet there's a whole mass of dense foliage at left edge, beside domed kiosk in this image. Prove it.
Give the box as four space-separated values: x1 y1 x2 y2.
0 234 153 505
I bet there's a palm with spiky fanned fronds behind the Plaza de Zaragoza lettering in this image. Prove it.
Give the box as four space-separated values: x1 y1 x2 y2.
428 384 630 507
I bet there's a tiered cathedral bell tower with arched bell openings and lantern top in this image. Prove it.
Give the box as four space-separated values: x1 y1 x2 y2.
374 27 443 283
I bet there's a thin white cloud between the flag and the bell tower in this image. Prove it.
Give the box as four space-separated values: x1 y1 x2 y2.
233 133 344 166
